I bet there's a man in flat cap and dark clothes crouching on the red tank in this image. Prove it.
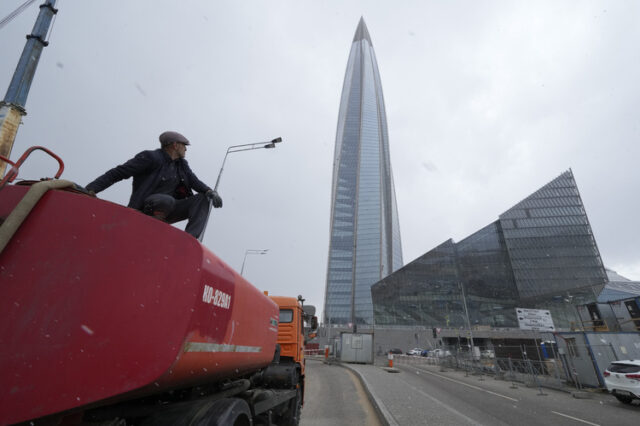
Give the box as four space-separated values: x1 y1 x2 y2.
86 131 222 238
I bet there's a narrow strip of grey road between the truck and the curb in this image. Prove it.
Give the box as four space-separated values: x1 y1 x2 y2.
300 359 380 426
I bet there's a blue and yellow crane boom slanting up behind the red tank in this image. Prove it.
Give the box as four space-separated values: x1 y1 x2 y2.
0 0 58 177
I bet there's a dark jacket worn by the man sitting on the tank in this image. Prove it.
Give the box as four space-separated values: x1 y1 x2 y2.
86 148 211 210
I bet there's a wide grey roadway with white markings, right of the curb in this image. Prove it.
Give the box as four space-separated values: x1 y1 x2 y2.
344 365 640 426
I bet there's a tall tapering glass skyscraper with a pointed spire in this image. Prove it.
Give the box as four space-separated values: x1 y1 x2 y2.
324 18 402 324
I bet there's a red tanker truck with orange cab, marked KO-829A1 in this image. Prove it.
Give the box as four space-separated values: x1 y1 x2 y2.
0 147 317 426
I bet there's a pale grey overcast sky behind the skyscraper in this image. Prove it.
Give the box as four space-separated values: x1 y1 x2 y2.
0 0 640 320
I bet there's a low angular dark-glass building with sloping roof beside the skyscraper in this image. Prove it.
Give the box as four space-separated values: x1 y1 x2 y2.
371 170 607 328
